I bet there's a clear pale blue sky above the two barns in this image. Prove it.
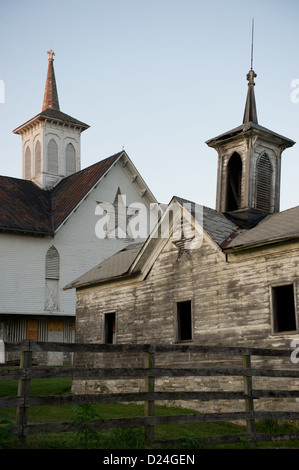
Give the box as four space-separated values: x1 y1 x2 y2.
0 0 299 209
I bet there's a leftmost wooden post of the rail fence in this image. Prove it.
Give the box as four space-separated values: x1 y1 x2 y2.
16 341 32 439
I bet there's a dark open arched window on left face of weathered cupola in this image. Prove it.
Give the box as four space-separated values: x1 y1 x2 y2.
226 152 242 212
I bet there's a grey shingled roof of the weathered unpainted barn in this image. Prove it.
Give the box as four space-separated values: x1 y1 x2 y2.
65 197 299 289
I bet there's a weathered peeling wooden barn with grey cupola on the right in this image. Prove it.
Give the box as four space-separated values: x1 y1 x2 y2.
66 70 299 412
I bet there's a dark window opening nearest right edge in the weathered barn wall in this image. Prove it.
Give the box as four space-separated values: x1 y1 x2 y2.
272 284 296 333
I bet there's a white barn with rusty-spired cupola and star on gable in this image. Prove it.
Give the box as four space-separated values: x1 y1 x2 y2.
0 51 156 362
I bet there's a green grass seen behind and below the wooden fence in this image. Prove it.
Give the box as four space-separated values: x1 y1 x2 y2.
0 372 299 449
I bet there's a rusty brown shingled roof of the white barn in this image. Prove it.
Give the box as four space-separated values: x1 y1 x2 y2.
0 152 124 235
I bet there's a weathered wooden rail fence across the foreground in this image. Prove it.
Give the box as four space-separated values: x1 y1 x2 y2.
0 341 299 443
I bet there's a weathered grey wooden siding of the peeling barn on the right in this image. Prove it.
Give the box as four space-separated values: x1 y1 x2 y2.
74 232 299 409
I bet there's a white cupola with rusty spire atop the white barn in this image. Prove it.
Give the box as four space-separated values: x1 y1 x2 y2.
13 50 89 189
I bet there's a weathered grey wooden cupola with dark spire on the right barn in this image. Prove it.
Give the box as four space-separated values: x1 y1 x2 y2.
206 69 295 226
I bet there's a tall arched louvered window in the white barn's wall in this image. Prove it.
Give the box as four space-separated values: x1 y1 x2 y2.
45 246 59 310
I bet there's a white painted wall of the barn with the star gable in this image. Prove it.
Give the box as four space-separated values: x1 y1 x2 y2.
0 162 155 316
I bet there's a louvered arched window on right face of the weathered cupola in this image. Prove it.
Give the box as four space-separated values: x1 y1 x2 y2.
256 153 273 212
